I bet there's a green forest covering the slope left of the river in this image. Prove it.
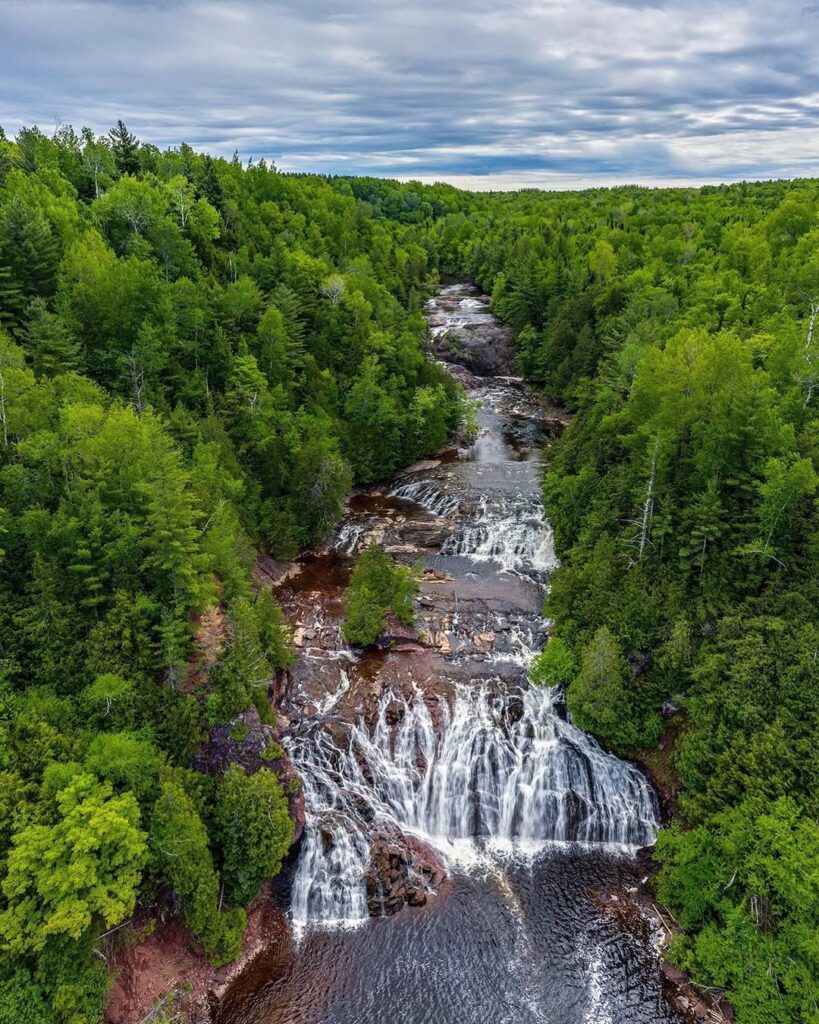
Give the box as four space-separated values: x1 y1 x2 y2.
0 121 464 1024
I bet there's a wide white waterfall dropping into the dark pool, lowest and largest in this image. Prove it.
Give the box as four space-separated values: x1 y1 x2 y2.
288 680 657 925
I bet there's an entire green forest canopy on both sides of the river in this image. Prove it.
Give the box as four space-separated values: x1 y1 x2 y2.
0 123 819 1024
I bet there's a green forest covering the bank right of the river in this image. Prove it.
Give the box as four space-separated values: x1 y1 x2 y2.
438 174 819 1024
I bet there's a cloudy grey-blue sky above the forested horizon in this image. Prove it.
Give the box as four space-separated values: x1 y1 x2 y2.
0 0 819 189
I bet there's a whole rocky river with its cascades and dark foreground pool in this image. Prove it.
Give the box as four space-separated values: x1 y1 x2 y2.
220 285 678 1024
